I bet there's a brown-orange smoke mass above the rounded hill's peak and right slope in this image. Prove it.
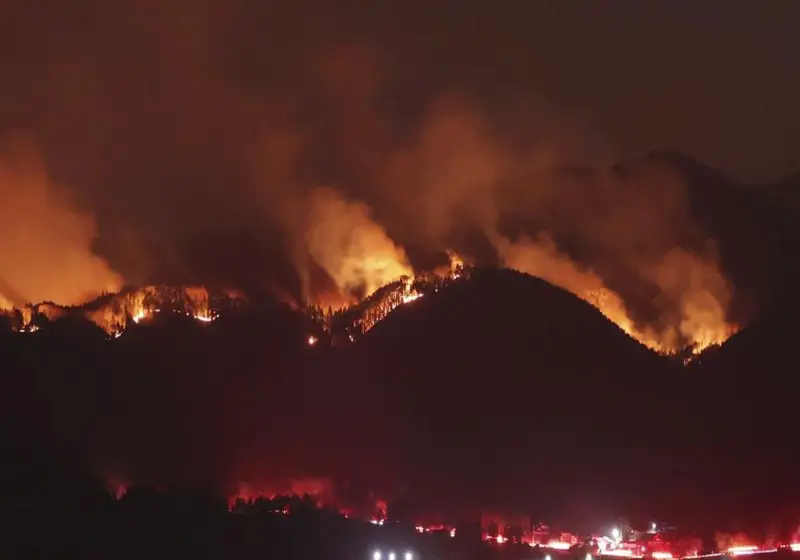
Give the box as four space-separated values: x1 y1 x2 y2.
362 95 731 351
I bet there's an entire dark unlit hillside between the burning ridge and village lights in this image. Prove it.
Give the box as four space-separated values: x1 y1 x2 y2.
0 270 788 532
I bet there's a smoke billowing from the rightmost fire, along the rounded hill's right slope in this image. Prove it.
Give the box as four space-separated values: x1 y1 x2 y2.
482 160 732 350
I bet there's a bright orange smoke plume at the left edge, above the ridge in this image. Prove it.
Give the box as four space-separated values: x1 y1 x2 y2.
0 138 121 306
